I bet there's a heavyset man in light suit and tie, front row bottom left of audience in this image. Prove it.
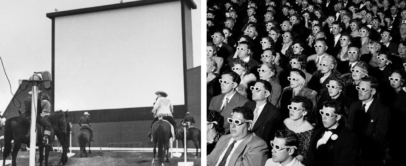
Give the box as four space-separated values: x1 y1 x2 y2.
207 107 268 166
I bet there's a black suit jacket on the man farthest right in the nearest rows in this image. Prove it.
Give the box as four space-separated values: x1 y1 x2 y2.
348 98 389 152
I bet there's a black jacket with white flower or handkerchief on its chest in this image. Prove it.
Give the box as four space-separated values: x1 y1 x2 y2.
304 124 359 166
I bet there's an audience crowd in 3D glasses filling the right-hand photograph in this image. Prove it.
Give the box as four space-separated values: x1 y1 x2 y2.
207 0 406 166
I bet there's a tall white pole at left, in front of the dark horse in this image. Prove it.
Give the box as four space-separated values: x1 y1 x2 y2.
30 82 38 166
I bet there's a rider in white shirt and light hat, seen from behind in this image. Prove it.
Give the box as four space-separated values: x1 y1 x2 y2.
148 91 176 137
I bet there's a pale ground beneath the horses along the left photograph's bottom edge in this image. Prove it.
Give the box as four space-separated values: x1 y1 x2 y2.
0 151 201 166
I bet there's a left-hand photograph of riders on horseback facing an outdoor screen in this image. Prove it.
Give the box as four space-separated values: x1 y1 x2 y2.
0 0 201 166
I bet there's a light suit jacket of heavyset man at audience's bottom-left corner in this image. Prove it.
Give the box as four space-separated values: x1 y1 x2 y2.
207 134 268 166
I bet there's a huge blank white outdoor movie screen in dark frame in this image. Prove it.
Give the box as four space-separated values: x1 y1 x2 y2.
55 1 185 110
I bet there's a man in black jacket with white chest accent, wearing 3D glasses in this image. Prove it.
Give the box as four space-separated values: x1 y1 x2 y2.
304 100 359 166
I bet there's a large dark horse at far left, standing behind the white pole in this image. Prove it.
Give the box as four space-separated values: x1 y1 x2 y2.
3 111 69 166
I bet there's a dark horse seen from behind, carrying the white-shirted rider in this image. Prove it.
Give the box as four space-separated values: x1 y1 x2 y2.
152 119 171 165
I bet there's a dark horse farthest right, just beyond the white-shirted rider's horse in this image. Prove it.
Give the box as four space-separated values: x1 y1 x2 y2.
176 127 201 158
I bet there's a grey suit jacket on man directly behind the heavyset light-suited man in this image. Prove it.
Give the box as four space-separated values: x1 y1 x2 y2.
209 92 248 133
